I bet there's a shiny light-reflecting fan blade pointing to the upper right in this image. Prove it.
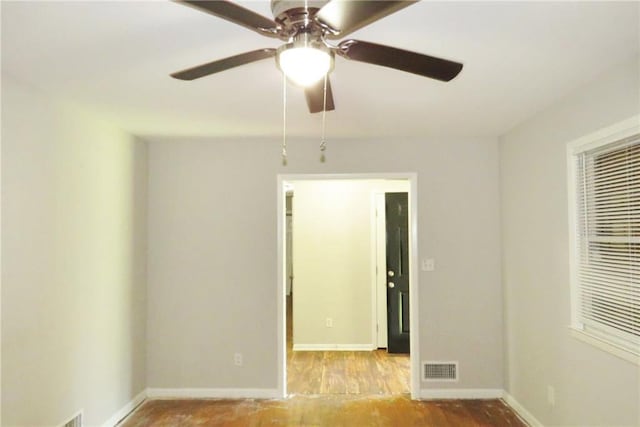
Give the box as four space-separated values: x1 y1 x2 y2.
316 0 417 39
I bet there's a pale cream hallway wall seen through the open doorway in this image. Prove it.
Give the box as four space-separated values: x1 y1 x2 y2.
293 180 409 349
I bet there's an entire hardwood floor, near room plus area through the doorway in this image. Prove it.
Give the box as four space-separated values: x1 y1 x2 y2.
119 298 526 427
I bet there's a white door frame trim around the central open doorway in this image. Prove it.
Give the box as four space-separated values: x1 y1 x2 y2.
276 172 420 400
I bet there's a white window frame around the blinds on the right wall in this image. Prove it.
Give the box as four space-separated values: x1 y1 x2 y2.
567 115 640 365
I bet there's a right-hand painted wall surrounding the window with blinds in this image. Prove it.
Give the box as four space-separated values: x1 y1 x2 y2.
500 59 640 426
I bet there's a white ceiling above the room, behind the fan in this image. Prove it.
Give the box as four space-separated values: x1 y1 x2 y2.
1 0 640 137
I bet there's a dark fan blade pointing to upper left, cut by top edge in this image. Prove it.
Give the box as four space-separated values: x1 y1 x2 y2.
176 0 280 37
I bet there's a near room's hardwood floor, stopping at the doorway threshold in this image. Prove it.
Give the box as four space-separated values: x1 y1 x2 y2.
121 395 526 427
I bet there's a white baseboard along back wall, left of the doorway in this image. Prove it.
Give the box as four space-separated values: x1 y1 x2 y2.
147 388 281 399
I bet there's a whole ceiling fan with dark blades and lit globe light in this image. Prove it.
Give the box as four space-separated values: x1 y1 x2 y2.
171 0 462 113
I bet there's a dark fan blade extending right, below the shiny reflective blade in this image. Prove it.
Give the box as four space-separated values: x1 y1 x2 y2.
337 40 462 82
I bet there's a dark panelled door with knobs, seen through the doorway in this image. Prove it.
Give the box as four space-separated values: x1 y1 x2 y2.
385 193 410 353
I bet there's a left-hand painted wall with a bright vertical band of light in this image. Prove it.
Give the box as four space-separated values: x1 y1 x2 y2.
2 74 146 426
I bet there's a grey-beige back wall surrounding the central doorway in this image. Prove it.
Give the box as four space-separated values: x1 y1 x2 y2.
147 135 503 390
